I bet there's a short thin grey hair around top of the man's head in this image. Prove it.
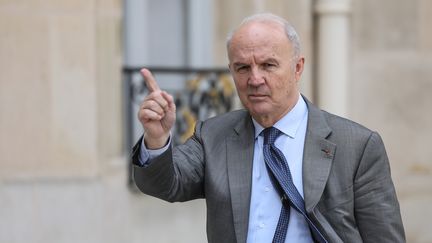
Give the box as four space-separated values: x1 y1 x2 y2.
226 13 301 57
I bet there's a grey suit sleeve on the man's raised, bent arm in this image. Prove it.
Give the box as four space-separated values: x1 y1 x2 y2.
132 123 204 202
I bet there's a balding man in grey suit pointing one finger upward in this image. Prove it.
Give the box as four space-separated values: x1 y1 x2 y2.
133 14 405 243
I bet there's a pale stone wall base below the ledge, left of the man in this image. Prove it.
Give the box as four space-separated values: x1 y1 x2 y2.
0 171 206 243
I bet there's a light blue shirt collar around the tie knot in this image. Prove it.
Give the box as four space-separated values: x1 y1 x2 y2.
252 95 308 139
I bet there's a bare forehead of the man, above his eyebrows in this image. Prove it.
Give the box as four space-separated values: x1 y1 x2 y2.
228 22 291 61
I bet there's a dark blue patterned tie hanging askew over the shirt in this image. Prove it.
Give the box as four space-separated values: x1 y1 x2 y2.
263 127 327 243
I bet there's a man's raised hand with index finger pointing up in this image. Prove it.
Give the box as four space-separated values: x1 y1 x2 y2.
138 68 176 149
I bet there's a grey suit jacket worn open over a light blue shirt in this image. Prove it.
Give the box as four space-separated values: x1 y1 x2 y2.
133 98 405 243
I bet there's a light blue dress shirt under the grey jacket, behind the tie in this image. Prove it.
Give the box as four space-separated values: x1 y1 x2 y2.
247 96 313 243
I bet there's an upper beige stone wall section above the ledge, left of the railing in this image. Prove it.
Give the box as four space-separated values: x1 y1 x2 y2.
0 0 124 180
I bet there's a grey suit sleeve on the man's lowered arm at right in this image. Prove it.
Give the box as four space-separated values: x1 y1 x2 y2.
354 133 405 243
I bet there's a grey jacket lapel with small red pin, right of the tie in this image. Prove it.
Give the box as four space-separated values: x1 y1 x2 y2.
303 99 336 212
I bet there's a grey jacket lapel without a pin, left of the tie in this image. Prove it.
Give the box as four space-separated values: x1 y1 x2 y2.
226 116 254 242
